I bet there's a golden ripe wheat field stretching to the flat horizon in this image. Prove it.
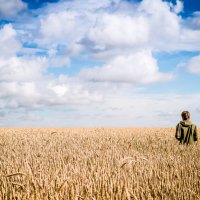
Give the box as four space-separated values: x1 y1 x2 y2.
0 128 200 200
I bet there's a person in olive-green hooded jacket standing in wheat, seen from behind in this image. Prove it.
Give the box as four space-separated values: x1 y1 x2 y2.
175 111 198 144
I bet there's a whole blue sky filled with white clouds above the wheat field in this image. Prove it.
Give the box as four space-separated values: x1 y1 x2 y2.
0 0 200 127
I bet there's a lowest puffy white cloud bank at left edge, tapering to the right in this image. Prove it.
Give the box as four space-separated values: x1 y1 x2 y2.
0 77 101 109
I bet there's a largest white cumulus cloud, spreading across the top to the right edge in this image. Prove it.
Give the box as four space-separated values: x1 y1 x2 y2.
35 0 200 55
